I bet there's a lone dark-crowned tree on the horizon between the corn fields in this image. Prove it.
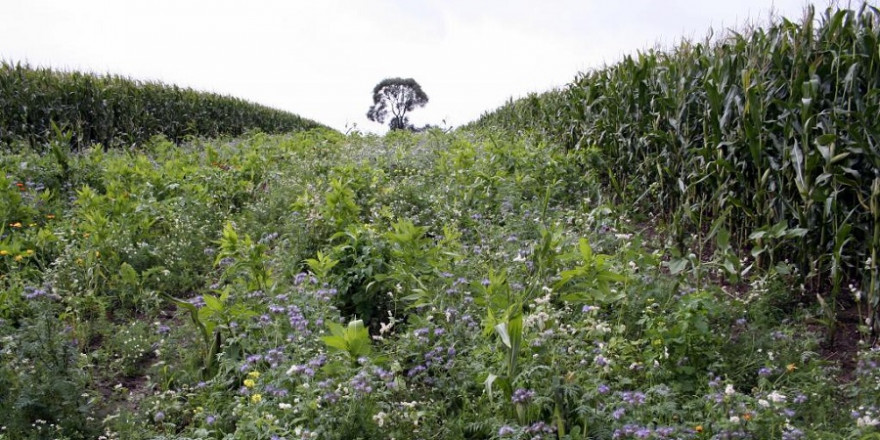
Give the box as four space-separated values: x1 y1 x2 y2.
367 78 428 130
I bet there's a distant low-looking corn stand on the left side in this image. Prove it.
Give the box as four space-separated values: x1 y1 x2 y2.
0 62 321 149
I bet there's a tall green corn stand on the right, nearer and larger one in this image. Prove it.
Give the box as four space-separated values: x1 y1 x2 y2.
477 4 880 334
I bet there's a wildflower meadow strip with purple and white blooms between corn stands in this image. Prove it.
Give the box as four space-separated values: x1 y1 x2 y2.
0 125 880 440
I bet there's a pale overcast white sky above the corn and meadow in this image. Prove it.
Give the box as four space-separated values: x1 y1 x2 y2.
0 0 827 133
